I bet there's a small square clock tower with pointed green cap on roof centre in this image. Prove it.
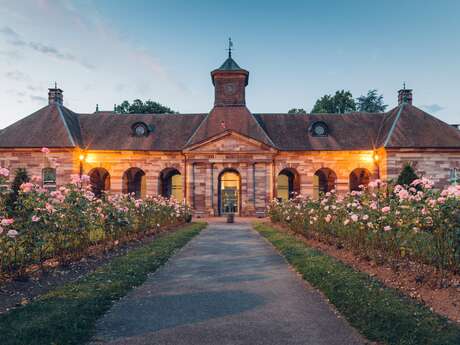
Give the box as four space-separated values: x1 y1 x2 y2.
211 46 249 107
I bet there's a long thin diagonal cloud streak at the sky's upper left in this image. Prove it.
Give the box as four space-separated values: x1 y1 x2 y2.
0 26 95 69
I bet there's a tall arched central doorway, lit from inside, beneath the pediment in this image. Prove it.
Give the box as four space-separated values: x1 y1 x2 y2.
218 169 241 215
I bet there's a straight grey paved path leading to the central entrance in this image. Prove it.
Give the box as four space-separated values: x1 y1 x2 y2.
95 219 365 345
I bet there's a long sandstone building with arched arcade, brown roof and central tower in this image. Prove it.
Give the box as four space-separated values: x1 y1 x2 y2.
0 52 460 215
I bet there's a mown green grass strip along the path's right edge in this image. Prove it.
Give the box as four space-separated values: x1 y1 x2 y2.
254 223 460 345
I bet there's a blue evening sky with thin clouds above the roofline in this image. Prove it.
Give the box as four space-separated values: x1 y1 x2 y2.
0 0 460 128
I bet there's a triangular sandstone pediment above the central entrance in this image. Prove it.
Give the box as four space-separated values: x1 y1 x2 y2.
184 131 276 153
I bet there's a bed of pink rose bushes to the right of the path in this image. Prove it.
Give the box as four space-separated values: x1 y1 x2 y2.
268 179 460 273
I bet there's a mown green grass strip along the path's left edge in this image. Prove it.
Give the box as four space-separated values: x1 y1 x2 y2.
0 223 206 345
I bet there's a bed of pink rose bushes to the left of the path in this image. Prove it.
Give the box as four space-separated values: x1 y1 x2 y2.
0 169 191 276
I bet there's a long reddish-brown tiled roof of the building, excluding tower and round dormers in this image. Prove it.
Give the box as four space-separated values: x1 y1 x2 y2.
0 104 460 151
